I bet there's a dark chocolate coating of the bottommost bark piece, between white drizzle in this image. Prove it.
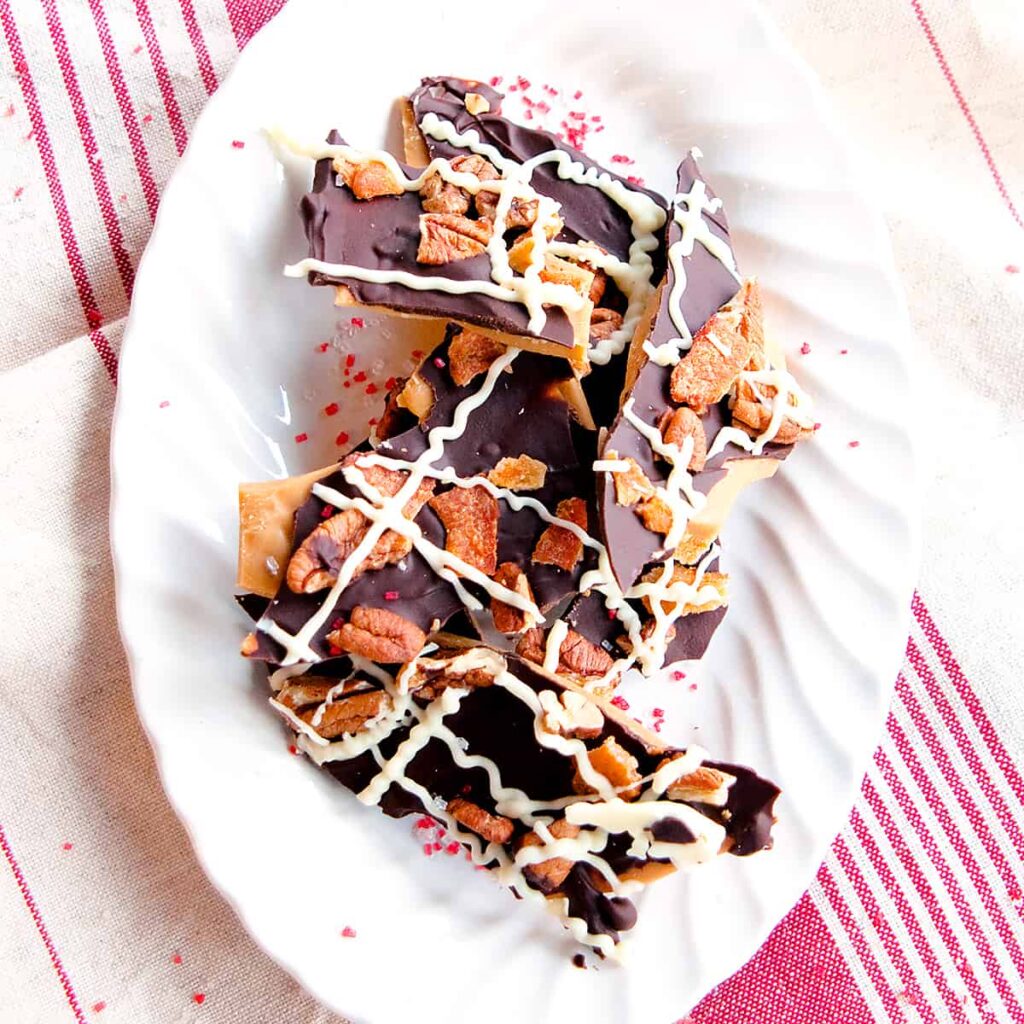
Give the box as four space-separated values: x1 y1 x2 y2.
309 656 779 941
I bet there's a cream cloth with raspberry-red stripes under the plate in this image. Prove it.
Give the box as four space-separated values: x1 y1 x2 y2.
0 0 1024 1024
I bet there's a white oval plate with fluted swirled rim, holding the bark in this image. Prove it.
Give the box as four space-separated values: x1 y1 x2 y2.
113 0 918 1024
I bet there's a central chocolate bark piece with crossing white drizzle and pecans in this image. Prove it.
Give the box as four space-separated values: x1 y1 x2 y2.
244 326 596 663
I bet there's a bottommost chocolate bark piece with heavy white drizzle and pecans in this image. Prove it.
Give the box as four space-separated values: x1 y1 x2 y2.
275 646 779 955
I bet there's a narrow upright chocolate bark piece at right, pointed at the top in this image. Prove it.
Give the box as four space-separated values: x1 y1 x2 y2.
596 156 811 667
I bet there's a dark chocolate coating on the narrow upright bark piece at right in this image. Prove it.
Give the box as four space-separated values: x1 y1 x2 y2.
595 156 792 598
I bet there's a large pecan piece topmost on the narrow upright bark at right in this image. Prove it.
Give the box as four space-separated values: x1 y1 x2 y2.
670 281 764 415
